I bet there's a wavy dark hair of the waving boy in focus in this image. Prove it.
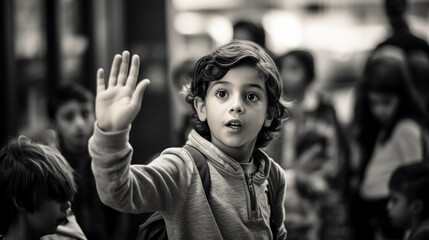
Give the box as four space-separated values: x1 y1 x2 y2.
186 40 289 148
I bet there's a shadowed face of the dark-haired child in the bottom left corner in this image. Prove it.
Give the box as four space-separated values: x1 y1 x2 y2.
24 198 70 236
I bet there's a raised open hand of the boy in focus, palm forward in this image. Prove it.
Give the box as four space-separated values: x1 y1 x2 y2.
95 51 150 131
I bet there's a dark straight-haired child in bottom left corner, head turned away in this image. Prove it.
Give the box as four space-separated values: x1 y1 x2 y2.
0 136 81 239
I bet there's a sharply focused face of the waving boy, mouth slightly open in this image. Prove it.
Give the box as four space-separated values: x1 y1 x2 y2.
196 66 271 154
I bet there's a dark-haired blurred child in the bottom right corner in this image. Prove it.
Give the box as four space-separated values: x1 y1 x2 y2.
387 163 429 240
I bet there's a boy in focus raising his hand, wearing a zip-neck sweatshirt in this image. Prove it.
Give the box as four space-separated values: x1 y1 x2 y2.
89 41 286 239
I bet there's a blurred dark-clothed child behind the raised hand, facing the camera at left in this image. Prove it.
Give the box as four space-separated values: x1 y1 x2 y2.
45 83 126 240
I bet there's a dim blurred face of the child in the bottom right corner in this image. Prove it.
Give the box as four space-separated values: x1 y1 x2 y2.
387 190 413 228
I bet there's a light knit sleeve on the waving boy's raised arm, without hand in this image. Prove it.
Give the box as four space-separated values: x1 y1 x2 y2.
89 124 193 213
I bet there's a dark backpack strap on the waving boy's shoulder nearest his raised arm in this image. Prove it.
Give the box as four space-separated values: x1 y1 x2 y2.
183 145 211 200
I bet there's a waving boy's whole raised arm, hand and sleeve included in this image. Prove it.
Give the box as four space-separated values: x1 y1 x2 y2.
89 51 192 212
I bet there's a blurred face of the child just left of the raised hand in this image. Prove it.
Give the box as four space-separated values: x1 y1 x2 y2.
55 100 95 151
